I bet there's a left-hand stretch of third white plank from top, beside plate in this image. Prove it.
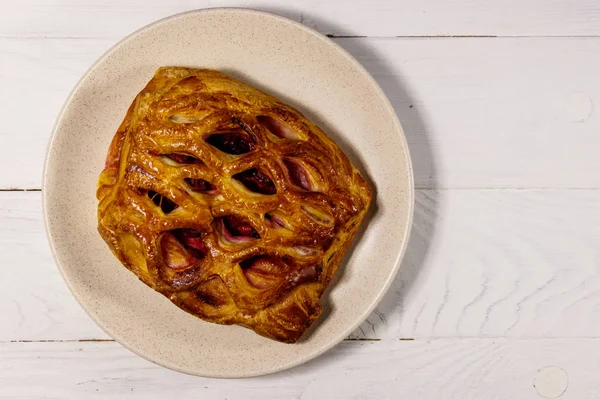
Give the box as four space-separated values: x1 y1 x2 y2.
0 192 109 340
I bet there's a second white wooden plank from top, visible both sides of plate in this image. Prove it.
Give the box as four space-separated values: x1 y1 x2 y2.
0 38 600 188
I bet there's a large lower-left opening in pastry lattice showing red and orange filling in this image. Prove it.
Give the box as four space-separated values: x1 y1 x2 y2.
160 228 208 269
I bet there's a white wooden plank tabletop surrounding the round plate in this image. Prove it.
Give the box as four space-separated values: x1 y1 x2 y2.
0 0 600 400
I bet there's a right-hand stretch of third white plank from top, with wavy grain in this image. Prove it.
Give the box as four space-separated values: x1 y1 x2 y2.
355 190 600 338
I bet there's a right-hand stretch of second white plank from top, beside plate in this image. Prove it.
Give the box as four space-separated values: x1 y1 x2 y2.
338 38 600 188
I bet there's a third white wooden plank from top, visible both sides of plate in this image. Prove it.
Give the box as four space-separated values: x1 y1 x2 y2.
0 190 600 341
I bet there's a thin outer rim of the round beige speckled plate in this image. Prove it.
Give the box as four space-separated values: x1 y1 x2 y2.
42 7 415 378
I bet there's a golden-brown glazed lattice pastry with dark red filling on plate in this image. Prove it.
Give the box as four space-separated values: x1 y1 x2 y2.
97 67 371 343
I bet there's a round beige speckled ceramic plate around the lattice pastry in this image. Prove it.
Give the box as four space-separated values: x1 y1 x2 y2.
43 9 413 377
